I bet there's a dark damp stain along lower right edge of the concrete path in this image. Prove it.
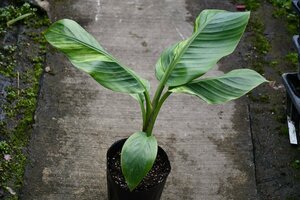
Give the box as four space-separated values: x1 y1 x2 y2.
209 105 258 200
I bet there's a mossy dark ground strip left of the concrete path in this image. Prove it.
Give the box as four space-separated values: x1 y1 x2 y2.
0 1 49 199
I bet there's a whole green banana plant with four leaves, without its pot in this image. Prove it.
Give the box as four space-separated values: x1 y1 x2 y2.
45 10 267 191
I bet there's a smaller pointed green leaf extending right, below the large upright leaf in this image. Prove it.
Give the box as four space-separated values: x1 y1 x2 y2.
170 69 267 104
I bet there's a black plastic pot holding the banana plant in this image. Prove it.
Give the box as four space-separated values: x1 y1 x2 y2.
106 139 171 200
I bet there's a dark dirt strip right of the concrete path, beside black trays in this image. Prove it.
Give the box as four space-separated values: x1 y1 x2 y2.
250 3 300 199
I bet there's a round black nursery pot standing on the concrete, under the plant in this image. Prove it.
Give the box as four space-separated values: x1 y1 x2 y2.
106 139 171 200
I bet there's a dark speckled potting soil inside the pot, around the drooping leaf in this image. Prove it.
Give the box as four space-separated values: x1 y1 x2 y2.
108 141 171 191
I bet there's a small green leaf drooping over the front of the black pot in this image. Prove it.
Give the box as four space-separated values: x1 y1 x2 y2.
121 132 157 191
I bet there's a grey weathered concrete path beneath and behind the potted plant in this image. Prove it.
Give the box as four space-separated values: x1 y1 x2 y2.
22 0 257 200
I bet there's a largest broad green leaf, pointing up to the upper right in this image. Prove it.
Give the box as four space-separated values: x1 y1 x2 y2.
156 10 250 86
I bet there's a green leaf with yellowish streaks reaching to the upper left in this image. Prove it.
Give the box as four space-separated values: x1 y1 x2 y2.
45 19 145 94
